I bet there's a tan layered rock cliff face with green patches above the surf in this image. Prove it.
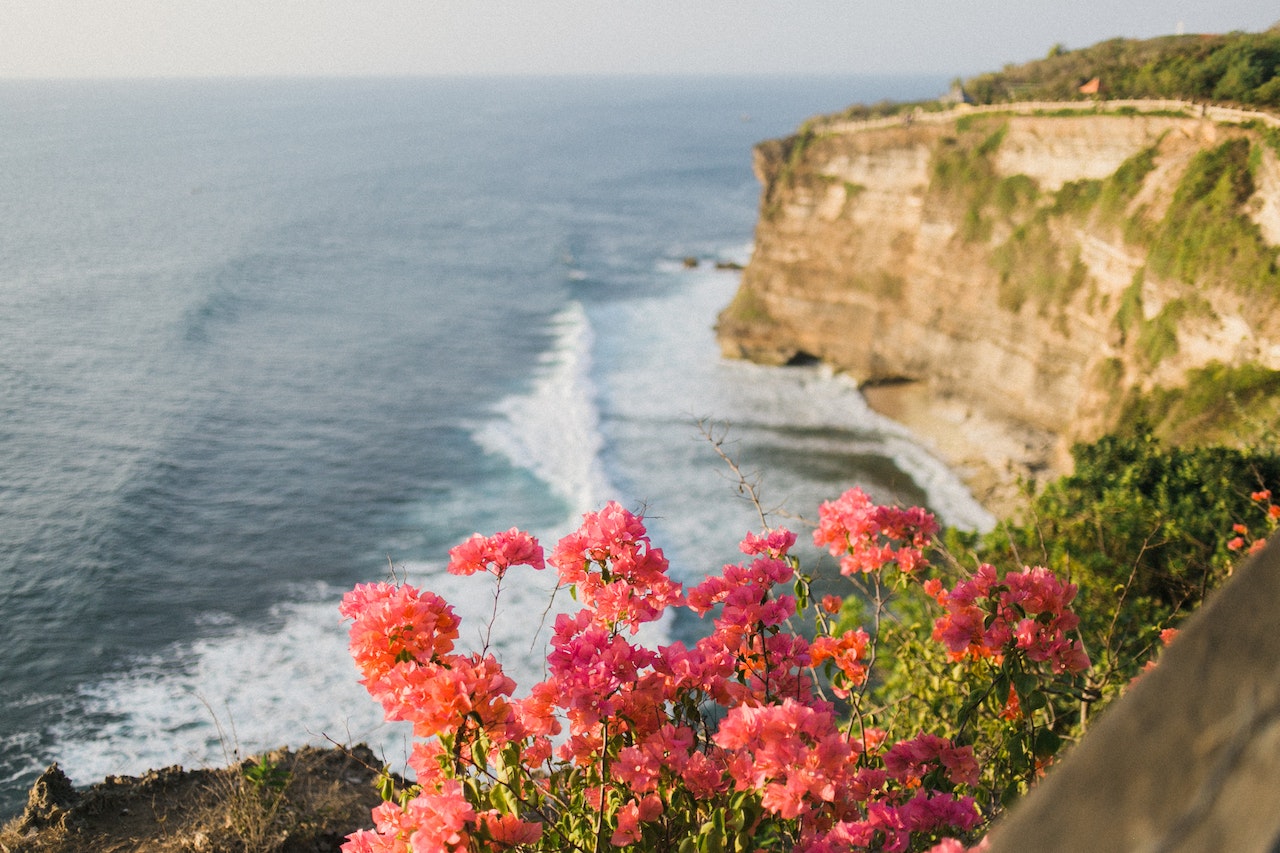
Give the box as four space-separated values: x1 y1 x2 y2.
717 105 1280 505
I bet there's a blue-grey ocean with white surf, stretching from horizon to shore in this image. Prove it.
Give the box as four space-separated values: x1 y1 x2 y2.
0 77 989 816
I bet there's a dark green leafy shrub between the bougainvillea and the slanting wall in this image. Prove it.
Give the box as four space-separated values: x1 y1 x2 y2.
962 429 1280 697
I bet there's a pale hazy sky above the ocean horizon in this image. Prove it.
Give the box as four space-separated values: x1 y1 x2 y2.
0 0 1280 78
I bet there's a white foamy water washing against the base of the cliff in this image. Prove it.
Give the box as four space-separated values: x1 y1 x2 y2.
593 258 993 535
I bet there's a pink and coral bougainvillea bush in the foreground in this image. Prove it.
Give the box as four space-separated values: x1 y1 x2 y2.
342 479 1141 853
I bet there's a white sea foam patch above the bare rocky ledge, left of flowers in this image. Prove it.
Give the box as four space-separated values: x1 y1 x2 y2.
46 589 410 784
